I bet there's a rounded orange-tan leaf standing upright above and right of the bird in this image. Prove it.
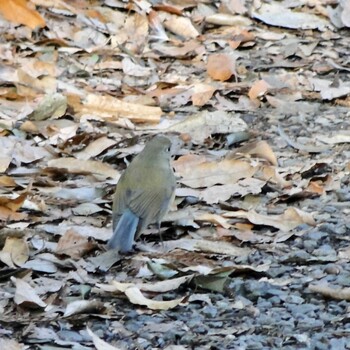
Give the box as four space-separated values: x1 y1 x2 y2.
207 54 236 81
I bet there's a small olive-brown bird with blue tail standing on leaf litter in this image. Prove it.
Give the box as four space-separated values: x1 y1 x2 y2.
107 135 176 253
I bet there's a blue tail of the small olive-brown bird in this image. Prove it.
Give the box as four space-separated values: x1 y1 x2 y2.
107 209 140 253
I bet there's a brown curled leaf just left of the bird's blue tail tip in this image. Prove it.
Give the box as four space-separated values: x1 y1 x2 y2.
56 230 95 260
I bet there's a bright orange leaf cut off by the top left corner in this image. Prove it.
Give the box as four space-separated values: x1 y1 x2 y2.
0 0 46 30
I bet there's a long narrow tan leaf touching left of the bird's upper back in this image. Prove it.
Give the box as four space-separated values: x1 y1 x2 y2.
47 158 119 179
